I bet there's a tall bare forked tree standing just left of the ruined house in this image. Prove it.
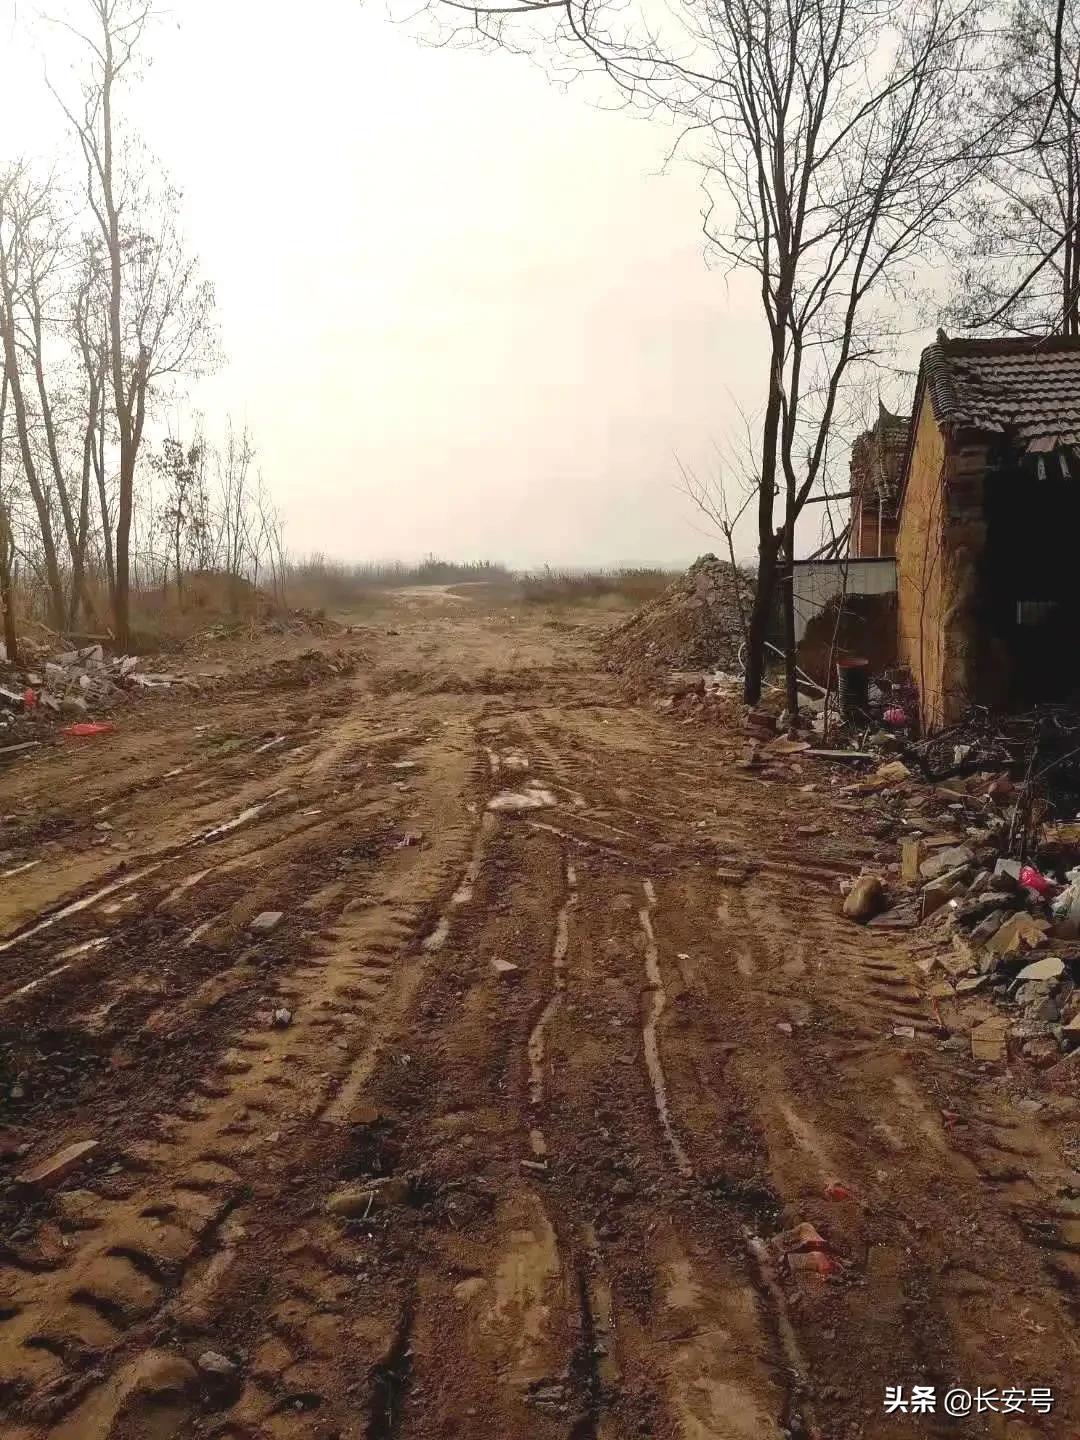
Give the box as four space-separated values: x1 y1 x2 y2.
414 0 988 704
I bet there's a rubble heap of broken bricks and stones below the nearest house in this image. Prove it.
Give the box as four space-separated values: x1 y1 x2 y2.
834 713 1080 1067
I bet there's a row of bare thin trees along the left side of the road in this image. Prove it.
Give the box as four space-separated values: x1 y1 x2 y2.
0 0 284 658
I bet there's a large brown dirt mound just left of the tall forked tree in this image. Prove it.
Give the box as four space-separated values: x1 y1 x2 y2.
603 554 752 671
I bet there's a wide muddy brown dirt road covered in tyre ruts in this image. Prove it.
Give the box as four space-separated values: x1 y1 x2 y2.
0 603 1080 1440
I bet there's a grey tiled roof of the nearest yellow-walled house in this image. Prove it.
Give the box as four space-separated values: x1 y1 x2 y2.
922 337 1080 452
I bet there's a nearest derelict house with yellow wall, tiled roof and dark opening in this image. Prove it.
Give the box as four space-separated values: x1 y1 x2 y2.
892 333 1080 729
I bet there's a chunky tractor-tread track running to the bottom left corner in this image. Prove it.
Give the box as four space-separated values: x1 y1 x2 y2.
0 711 472 1436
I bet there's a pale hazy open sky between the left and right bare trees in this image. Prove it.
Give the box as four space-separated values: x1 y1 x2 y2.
0 0 892 566
